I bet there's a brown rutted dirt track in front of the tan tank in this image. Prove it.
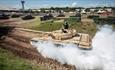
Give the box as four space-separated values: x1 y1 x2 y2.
0 29 75 70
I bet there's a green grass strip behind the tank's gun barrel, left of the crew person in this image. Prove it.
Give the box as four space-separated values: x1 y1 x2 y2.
21 17 63 31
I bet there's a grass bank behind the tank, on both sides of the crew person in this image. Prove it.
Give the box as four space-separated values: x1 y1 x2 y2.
20 18 97 37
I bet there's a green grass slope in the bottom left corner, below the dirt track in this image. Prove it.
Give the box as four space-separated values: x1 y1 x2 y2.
0 48 47 70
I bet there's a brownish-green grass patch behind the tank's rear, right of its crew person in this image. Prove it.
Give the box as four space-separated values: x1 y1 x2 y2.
71 22 97 37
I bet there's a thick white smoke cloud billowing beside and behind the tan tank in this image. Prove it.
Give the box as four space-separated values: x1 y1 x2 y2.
31 25 115 70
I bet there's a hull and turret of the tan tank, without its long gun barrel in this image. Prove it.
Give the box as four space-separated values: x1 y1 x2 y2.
31 29 92 50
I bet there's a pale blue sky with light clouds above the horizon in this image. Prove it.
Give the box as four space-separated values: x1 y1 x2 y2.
0 0 115 9
